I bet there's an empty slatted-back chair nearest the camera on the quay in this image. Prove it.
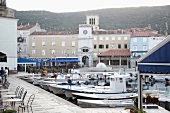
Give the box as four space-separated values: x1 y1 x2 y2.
18 94 35 113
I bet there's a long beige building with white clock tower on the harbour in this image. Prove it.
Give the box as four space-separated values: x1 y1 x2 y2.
29 14 130 67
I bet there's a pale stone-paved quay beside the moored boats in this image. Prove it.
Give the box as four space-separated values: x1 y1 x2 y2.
4 72 169 113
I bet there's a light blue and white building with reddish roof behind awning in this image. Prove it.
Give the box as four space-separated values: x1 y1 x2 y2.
130 30 166 67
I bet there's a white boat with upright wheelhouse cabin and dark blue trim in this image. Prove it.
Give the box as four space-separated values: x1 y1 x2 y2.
62 74 136 99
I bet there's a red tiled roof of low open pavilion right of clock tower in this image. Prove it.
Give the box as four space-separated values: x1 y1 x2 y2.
98 49 131 57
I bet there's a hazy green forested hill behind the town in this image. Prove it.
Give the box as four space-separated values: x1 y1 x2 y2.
15 6 170 33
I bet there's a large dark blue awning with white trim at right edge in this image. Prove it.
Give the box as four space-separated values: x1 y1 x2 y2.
138 36 170 74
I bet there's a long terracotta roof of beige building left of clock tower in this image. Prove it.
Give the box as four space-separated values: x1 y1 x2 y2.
31 31 79 35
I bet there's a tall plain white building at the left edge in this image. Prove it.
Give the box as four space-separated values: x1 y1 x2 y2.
0 0 18 71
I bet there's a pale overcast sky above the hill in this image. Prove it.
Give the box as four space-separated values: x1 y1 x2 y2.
6 0 170 12
